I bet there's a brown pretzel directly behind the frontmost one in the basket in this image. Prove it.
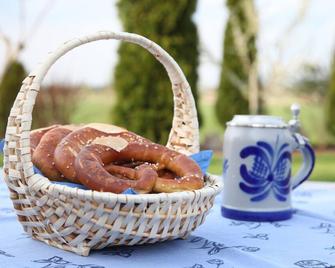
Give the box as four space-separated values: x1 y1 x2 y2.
55 123 150 183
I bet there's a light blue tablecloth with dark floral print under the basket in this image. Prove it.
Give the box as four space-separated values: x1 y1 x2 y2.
0 175 335 268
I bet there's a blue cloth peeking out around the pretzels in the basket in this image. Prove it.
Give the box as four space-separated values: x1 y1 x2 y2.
0 139 213 194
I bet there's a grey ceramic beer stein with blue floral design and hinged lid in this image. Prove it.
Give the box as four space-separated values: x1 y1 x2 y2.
221 107 315 221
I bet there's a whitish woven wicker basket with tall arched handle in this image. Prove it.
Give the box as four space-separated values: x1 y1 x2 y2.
4 32 222 256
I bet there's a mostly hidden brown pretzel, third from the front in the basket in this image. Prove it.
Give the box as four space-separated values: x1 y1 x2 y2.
32 125 76 180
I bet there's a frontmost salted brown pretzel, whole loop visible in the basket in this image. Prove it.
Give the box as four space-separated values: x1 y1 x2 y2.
75 136 204 193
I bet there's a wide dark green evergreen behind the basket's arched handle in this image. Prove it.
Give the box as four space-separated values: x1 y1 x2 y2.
112 0 199 144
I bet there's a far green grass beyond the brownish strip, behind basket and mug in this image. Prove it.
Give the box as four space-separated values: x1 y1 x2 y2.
71 90 335 146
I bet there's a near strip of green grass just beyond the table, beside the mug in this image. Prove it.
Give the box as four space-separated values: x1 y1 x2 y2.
208 151 335 182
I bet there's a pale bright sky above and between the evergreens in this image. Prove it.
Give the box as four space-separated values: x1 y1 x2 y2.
0 0 335 89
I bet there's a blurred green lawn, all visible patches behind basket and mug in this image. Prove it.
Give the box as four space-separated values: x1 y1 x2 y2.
0 90 335 182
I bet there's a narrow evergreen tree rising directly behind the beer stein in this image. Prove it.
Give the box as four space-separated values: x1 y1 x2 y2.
215 0 261 127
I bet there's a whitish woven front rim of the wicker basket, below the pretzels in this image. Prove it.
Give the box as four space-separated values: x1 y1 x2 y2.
28 173 223 203
